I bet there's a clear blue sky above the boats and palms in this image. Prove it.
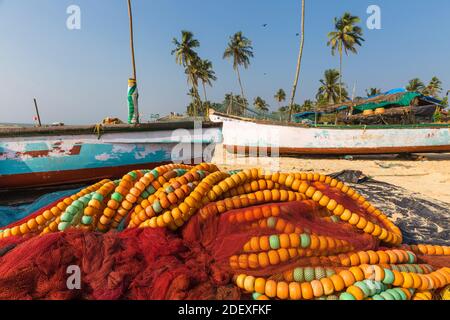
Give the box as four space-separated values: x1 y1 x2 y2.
0 0 450 124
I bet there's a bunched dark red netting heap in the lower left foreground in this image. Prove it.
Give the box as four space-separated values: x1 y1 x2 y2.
0 229 240 300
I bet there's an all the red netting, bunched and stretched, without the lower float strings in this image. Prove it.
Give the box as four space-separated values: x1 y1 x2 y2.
0 201 442 300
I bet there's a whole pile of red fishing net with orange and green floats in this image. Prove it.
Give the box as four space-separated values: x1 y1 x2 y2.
0 164 450 300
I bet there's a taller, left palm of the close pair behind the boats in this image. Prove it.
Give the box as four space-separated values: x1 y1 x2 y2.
172 30 201 113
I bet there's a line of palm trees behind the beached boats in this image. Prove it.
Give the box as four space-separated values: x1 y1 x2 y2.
172 0 442 120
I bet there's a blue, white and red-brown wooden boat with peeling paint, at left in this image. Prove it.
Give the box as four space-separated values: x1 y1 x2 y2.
0 122 221 190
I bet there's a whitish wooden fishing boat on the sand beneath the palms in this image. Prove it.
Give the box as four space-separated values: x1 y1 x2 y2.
209 110 450 155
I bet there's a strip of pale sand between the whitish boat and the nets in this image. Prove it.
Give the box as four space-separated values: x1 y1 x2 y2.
212 147 450 203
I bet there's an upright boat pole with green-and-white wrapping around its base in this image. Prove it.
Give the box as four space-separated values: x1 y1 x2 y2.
128 0 139 124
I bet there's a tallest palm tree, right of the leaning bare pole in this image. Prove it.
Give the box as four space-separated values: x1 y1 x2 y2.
327 12 364 102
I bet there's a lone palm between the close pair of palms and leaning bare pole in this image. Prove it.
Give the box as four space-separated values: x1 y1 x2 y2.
223 31 253 104
